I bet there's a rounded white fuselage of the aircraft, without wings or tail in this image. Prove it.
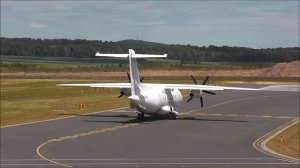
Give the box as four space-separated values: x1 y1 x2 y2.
129 84 182 115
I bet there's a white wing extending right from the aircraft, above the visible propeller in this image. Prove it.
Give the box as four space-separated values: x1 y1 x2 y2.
148 84 260 91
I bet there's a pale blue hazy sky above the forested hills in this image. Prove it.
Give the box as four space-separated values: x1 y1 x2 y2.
1 0 299 48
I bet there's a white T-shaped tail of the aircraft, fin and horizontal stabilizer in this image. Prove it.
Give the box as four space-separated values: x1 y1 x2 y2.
95 49 167 95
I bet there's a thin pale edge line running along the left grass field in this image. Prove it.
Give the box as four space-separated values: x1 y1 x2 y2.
0 107 128 129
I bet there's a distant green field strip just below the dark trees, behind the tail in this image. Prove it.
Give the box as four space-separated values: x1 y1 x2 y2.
1 56 274 72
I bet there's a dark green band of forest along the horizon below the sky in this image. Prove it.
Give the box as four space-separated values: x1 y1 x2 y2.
1 37 299 64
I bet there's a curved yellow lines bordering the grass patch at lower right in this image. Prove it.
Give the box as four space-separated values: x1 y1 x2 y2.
252 118 300 163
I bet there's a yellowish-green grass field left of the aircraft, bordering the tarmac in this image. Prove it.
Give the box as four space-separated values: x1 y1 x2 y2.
1 79 128 126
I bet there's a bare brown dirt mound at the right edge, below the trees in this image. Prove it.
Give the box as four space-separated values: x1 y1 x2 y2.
262 61 300 77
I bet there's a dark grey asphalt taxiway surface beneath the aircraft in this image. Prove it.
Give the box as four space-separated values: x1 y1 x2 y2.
1 86 299 168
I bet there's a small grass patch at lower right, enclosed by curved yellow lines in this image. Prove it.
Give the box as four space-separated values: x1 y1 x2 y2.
267 122 300 159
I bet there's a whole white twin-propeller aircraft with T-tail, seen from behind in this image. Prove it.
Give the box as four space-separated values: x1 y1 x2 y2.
58 49 258 119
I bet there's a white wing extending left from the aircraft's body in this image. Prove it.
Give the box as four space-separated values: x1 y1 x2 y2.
57 83 131 88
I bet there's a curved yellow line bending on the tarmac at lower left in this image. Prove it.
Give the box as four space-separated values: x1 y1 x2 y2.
36 123 139 167
